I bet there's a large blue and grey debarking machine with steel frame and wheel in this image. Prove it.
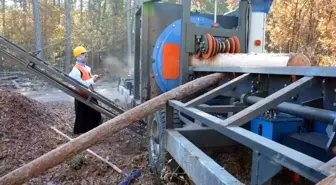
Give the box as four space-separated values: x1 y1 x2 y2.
134 0 336 185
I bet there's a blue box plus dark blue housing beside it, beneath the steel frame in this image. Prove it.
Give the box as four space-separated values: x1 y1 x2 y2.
250 114 331 162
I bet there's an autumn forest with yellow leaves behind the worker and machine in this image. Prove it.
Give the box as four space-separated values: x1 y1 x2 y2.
0 0 336 74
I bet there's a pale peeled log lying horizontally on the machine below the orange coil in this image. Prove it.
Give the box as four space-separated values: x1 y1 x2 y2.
189 53 311 67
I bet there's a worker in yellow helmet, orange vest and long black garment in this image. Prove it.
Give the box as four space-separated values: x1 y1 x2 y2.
69 46 102 134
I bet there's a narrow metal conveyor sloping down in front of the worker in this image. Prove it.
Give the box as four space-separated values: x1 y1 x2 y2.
0 36 125 118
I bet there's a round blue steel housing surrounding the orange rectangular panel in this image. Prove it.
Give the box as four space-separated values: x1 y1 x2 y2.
152 16 222 93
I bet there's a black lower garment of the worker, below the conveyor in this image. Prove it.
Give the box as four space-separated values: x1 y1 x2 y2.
73 99 102 134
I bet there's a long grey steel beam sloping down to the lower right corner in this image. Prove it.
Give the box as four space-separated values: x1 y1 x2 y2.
169 100 330 183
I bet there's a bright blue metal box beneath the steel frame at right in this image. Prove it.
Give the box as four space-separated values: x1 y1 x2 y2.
251 115 306 143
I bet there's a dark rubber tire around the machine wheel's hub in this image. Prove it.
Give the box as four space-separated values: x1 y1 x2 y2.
148 109 182 176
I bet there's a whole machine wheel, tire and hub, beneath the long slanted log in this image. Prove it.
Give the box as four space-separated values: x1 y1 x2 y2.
148 109 181 176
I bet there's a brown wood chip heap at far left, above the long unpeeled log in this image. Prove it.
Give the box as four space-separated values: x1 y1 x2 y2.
0 90 66 180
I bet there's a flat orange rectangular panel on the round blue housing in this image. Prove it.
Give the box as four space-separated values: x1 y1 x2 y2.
162 44 180 80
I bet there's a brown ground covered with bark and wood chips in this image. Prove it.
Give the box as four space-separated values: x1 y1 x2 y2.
0 89 312 185
